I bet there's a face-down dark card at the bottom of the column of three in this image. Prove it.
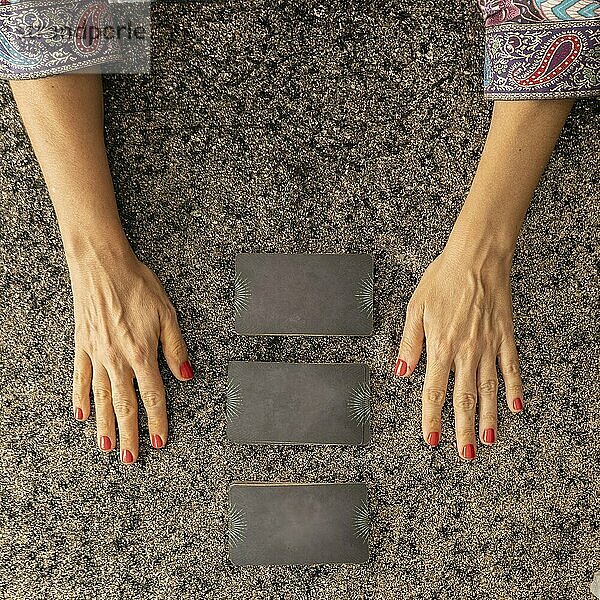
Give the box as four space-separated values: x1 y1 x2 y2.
229 483 369 565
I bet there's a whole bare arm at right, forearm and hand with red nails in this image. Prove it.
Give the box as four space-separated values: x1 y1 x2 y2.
394 99 573 459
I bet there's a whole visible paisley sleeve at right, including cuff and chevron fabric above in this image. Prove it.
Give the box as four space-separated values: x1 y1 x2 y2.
479 0 600 100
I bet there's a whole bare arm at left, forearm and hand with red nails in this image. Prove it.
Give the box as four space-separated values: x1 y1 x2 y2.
11 74 194 463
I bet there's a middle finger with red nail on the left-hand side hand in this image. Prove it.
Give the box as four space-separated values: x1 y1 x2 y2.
108 368 138 464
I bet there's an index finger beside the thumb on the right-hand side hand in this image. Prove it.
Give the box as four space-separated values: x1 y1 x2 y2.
421 344 451 447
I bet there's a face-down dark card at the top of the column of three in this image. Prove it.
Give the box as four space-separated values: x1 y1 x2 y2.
234 254 373 335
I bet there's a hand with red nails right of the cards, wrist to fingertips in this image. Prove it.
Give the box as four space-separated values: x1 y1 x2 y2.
394 244 523 459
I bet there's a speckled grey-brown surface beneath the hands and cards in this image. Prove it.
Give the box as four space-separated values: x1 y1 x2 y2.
0 0 600 600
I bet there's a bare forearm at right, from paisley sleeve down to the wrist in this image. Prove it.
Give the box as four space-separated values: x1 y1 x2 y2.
448 100 573 261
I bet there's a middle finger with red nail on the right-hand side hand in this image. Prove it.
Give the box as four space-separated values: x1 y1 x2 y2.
453 360 477 460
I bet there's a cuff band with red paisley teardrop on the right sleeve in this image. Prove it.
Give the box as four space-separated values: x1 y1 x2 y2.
483 20 600 100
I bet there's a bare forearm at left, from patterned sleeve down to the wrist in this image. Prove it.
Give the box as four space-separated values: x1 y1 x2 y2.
11 74 130 264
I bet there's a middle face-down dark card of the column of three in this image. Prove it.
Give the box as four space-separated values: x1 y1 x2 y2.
226 361 371 445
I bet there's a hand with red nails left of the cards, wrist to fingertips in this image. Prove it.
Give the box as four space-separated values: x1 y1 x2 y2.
69 250 193 463
